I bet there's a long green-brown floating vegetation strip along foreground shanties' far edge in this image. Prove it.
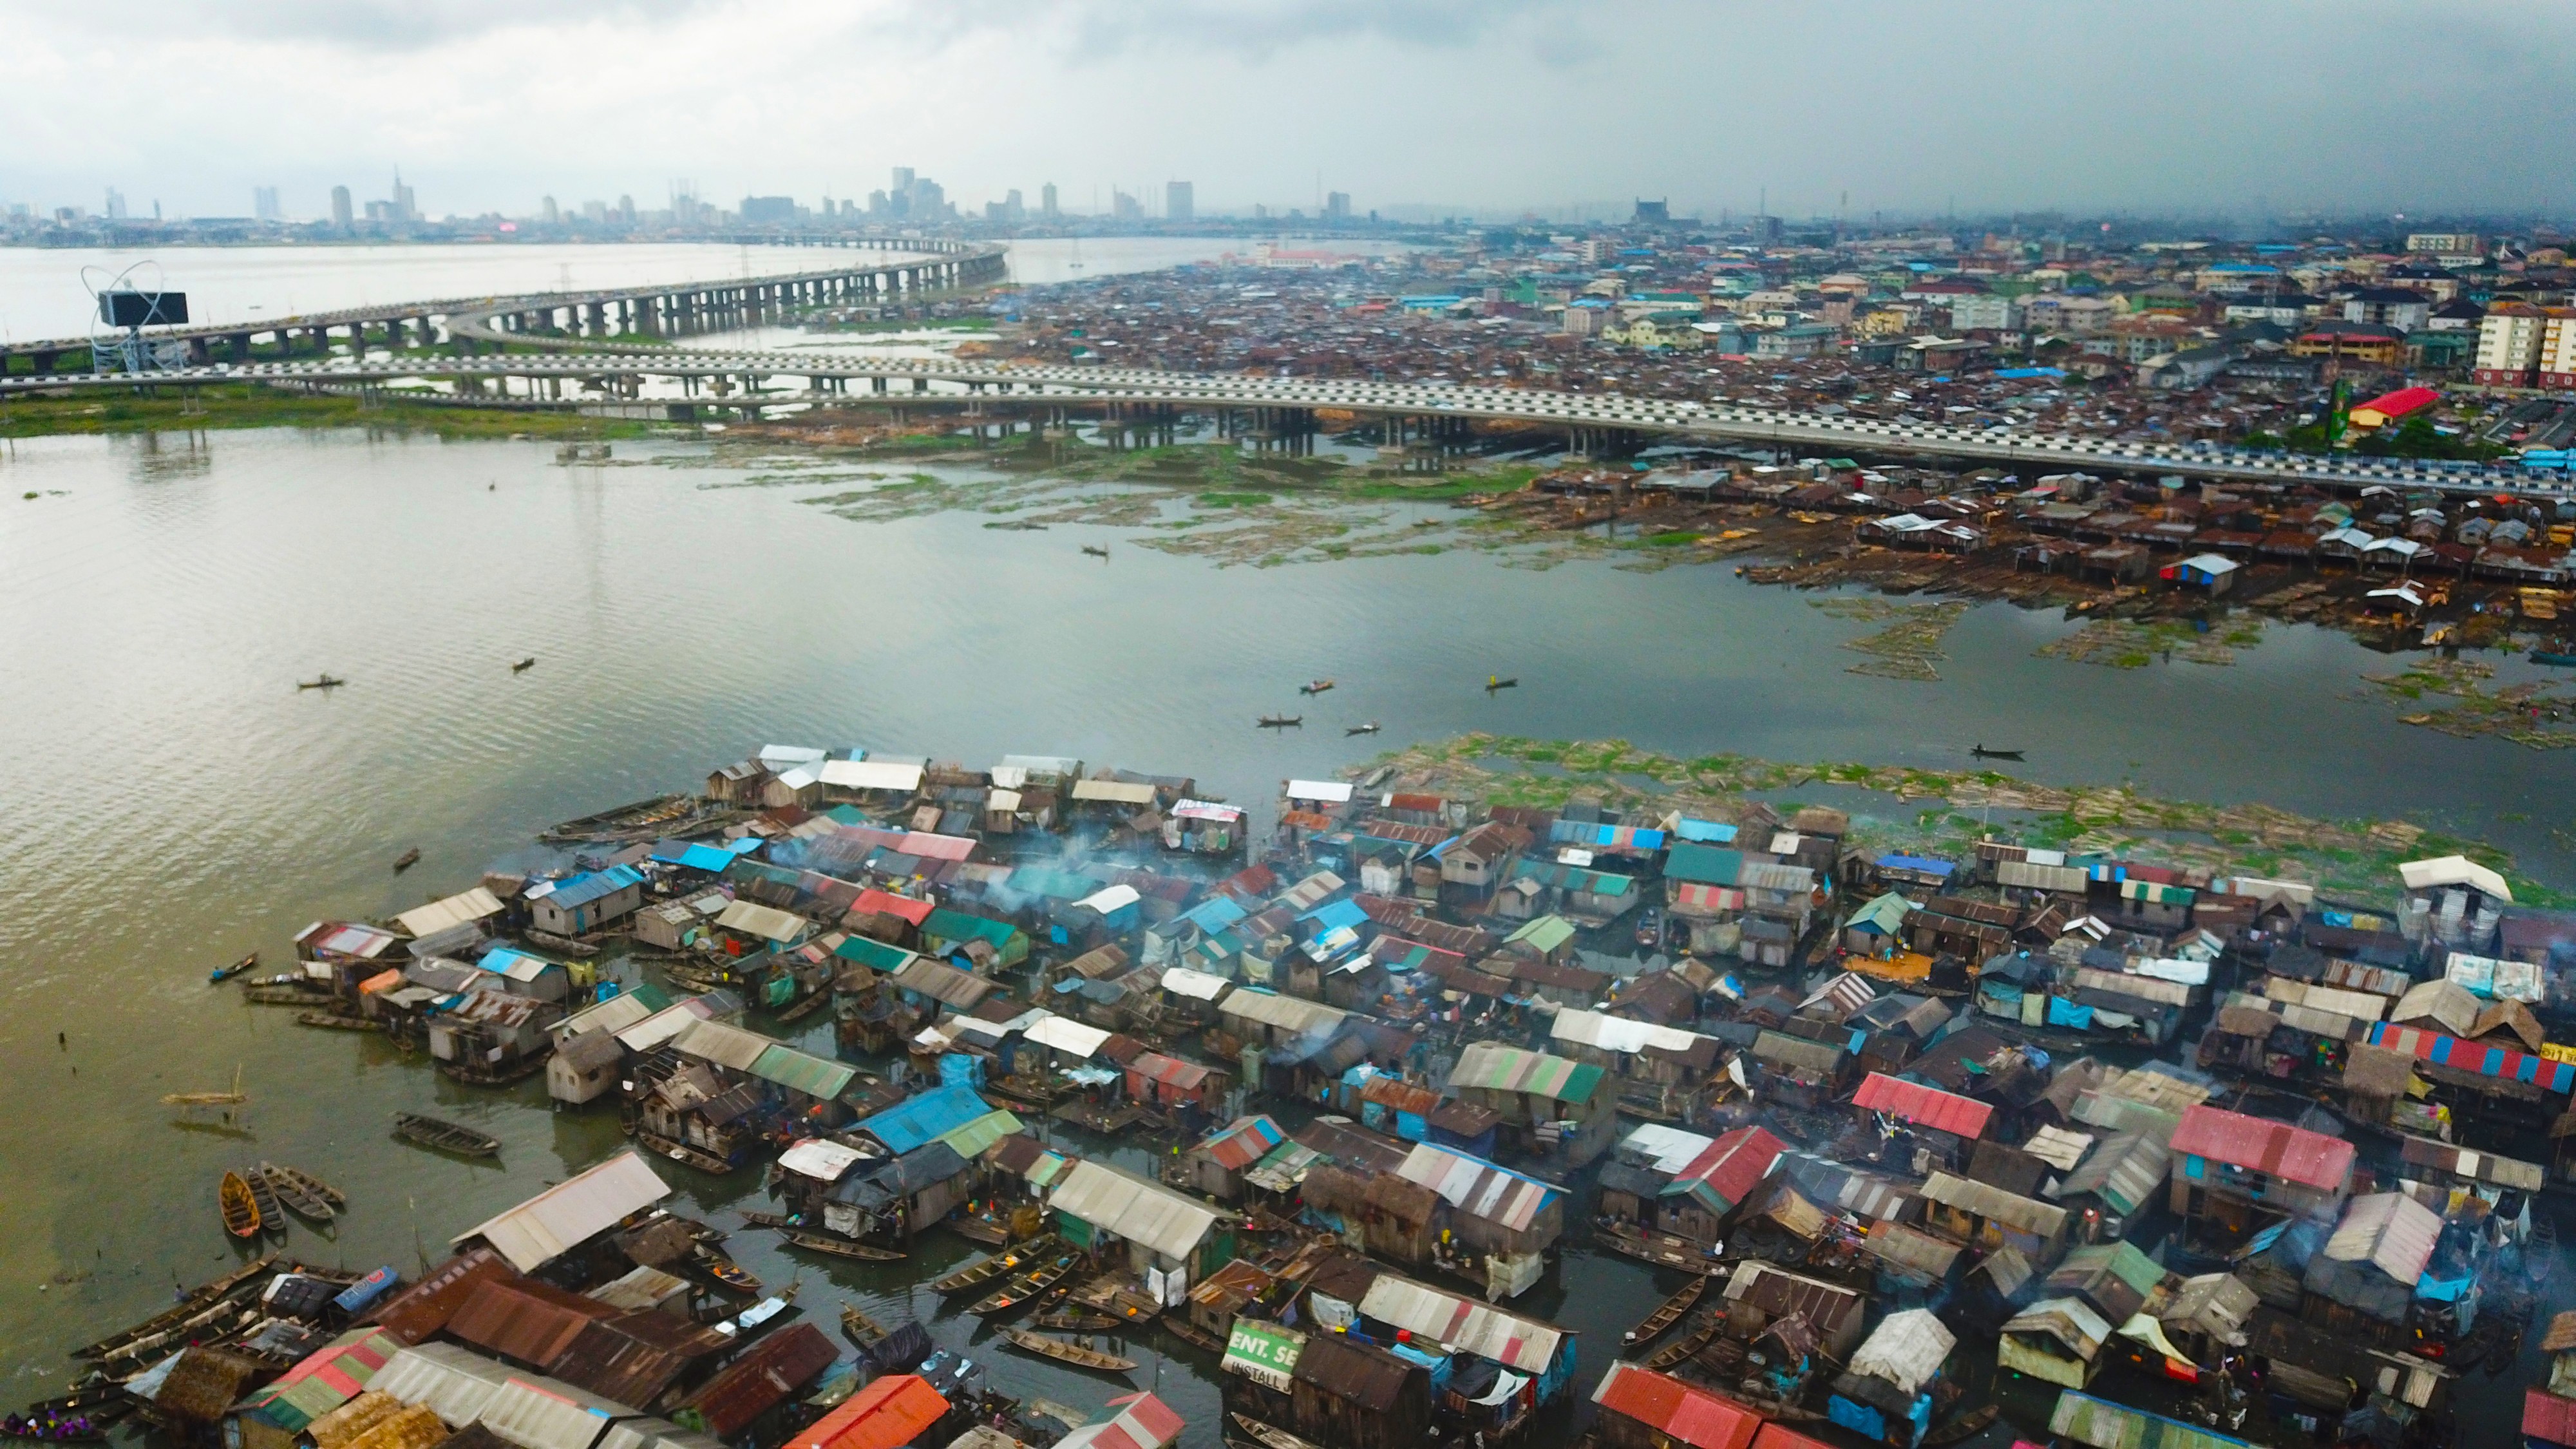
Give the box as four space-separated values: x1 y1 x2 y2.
1345 732 2576 905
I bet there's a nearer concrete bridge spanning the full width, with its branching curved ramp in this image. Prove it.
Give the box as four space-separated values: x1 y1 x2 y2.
0 256 2576 498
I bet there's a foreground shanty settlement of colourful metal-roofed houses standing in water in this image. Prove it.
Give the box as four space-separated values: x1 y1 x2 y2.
65 745 2576 1449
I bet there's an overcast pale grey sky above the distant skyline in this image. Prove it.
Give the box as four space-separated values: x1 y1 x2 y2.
0 0 2576 219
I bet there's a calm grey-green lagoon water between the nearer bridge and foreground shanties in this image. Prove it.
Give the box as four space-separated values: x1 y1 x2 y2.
0 242 2576 1444
